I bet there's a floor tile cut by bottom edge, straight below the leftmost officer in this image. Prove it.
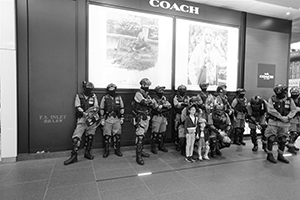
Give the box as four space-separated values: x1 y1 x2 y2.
44 183 100 200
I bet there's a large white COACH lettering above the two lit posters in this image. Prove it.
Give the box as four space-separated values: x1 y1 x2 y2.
149 0 199 14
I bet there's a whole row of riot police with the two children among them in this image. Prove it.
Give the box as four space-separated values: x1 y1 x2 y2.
64 78 300 165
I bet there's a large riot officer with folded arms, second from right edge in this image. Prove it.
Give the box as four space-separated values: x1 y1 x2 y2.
265 84 296 164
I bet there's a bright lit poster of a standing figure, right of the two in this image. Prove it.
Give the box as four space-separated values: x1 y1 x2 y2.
175 19 239 91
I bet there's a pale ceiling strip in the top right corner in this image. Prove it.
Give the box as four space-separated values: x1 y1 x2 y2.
186 0 300 43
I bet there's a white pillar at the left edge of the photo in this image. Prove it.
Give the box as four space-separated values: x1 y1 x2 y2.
0 0 17 162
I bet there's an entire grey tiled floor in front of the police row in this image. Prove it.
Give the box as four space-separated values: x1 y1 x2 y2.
0 140 300 200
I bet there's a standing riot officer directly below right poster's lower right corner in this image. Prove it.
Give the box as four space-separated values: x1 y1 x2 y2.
231 88 247 146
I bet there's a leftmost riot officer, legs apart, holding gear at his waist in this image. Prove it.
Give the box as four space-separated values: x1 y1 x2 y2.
64 81 100 165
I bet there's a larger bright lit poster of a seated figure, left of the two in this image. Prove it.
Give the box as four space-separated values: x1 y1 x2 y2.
88 5 173 89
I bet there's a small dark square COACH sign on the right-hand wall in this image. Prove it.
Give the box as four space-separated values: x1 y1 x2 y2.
257 63 275 88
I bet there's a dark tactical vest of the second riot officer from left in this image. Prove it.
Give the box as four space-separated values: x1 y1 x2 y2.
103 94 121 117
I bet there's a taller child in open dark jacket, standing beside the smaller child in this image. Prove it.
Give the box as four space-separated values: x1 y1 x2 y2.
184 105 198 162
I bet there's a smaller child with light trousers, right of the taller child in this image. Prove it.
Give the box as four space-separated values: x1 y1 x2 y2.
196 118 209 161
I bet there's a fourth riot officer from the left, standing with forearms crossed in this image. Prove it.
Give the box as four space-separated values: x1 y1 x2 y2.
151 86 172 154
